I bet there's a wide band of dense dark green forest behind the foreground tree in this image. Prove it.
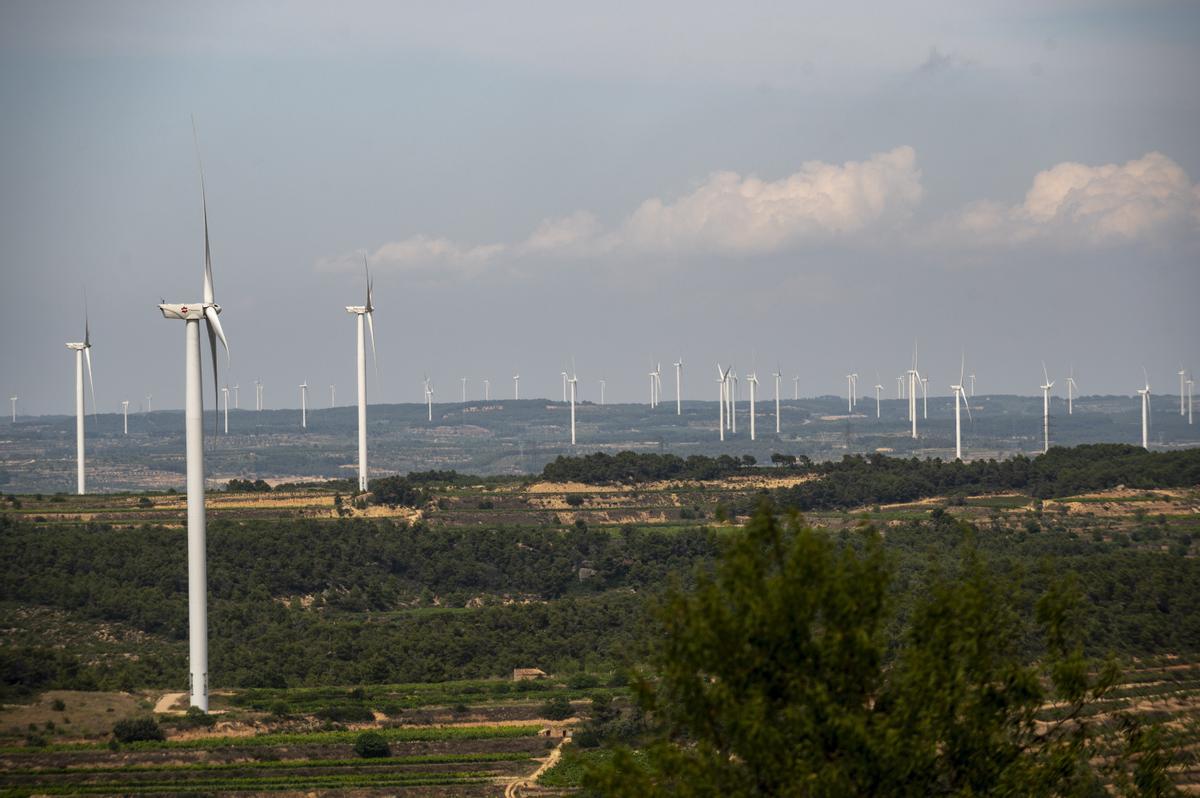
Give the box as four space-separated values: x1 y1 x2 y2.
0 511 1200 690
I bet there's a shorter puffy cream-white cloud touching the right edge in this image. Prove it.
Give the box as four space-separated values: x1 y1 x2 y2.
931 152 1200 247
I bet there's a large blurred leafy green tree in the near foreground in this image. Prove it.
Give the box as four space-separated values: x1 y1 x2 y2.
586 502 1169 796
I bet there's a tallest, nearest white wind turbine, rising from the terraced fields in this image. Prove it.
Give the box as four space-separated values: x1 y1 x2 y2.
158 126 229 713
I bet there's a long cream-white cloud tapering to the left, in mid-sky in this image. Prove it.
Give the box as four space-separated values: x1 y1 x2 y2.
331 146 922 276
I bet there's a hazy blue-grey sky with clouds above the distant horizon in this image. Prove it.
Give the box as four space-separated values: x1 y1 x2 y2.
0 0 1200 414
